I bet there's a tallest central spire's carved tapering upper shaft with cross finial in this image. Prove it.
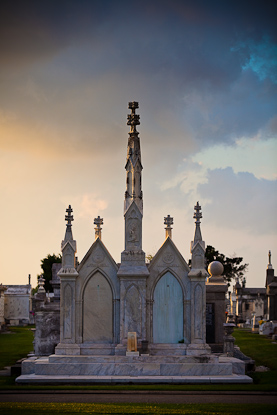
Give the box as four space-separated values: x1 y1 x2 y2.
124 101 143 214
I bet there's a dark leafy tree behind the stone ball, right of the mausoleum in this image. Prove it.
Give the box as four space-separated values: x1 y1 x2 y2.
205 245 249 286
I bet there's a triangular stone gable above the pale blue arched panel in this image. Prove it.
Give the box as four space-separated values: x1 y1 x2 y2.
149 237 190 272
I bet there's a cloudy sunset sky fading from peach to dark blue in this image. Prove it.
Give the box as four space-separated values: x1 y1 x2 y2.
0 0 277 287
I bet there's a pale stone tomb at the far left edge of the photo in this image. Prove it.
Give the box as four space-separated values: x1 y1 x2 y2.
4 285 31 325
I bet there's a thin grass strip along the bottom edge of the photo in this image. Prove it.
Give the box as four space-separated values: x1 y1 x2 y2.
0 402 276 415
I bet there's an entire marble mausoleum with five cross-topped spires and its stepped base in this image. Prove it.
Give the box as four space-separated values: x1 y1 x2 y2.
17 102 251 383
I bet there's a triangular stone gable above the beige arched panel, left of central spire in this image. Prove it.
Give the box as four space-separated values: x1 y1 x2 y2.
77 238 118 272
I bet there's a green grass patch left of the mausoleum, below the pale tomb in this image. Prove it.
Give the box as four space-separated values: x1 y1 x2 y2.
0 326 34 369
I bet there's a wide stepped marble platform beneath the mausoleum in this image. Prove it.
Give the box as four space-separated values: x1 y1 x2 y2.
16 355 252 383
